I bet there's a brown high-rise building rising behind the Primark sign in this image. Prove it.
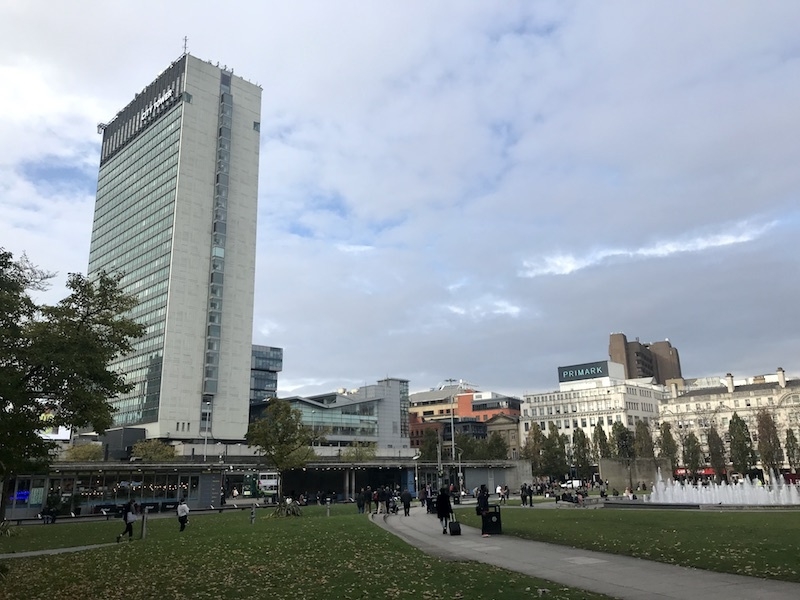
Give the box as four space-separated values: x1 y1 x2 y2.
608 333 681 385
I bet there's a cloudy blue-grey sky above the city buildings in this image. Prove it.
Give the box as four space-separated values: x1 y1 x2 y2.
0 0 800 396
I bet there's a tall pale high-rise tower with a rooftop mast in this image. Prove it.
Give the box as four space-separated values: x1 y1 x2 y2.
89 54 261 440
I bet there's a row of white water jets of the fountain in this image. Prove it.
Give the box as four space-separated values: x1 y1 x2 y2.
645 469 800 506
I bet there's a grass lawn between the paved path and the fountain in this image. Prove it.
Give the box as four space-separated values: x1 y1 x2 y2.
458 507 800 582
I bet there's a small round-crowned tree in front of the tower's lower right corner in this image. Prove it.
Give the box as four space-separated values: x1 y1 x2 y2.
245 398 317 496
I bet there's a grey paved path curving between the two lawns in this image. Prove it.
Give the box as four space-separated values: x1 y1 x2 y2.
372 503 800 600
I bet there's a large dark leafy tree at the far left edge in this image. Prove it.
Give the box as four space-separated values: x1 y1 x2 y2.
0 249 144 514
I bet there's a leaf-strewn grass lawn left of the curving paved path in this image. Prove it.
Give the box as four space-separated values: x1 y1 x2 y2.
0 505 606 600
